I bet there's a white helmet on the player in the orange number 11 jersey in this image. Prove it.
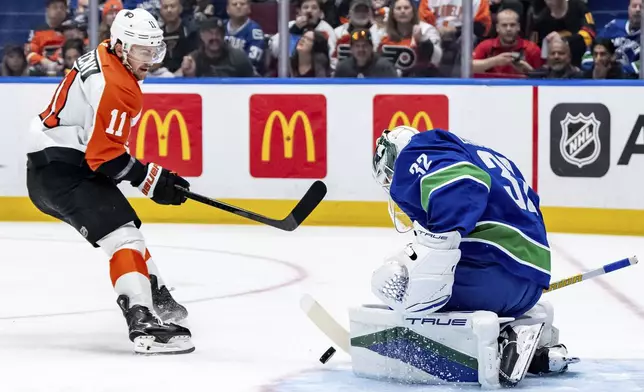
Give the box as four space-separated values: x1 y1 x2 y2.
110 8 166 64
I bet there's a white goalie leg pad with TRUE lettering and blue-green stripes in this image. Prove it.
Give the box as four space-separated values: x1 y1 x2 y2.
349 305 500 388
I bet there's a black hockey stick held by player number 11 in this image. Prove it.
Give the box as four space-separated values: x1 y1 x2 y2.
175 180 326 231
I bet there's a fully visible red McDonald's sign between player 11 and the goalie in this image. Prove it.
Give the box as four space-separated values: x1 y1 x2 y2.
250 94 326 178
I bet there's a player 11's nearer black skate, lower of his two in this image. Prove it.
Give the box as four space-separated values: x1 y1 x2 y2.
116 295 195 354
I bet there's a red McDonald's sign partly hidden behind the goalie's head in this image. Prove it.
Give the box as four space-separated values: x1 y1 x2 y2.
372 95 449 146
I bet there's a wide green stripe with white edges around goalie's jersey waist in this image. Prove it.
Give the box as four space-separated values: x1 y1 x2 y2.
463 221 550 275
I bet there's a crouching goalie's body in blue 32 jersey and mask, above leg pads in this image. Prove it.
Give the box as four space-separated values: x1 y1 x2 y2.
374 127 550 317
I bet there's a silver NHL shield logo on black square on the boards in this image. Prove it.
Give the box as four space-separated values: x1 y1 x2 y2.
559 113 602 168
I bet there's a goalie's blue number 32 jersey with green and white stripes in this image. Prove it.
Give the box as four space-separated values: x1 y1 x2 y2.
390 130 550 288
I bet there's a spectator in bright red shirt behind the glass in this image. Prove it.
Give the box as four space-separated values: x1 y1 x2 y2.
472 9 543 76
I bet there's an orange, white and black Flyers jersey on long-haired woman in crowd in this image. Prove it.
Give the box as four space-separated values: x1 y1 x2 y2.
374 22 443 71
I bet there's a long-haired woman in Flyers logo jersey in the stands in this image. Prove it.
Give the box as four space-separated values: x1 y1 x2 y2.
377 0 442 73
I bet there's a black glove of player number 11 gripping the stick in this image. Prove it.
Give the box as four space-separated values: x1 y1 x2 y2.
132 163 190 206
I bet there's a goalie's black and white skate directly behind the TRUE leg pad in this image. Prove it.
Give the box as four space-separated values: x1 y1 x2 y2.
499 323 544 387
